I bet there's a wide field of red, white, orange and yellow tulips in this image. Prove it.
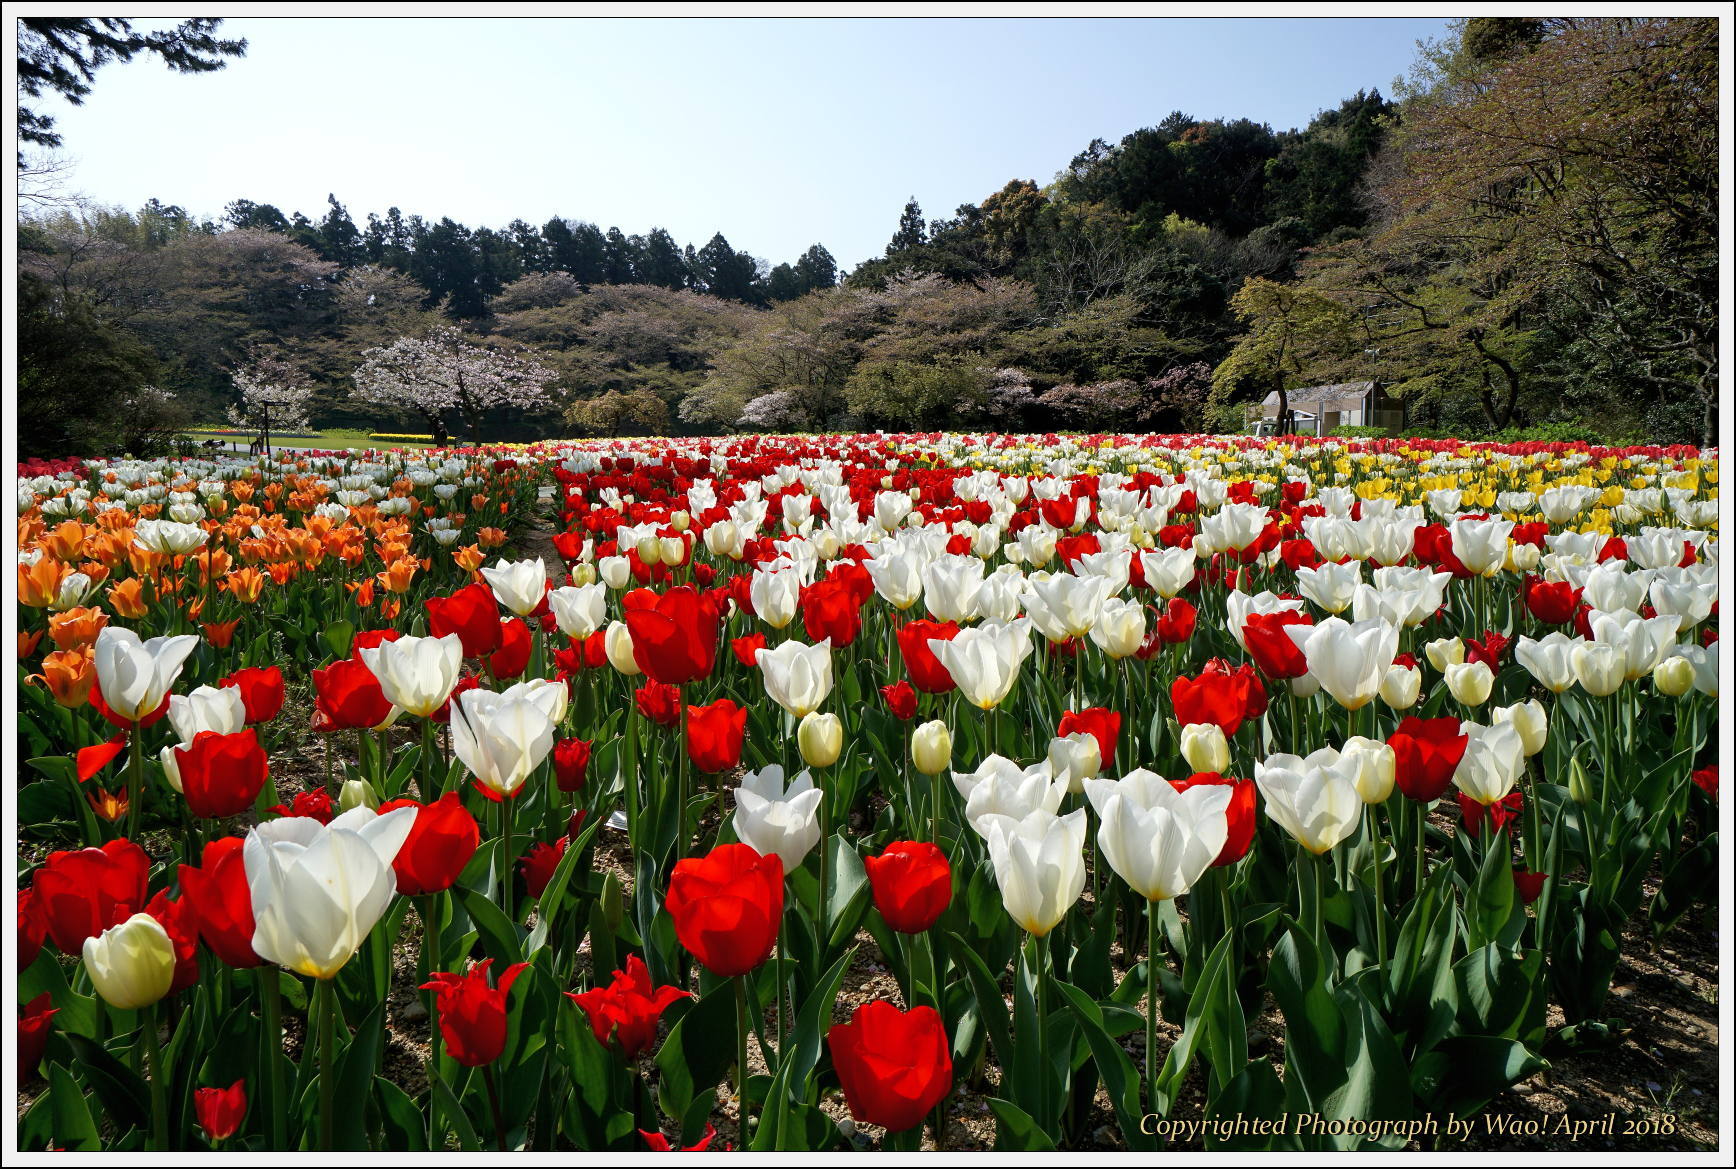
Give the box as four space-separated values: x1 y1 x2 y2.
14 434 1720 1153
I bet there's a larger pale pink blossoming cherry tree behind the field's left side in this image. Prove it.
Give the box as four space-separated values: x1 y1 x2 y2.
352 325 557 441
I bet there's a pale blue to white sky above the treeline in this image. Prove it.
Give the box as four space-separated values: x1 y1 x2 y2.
43 17 1446 267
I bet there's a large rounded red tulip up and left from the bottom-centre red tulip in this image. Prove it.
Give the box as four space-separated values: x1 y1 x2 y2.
663 844 783 978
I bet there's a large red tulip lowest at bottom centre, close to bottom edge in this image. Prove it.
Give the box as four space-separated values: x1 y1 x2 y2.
826 999 953 1133
